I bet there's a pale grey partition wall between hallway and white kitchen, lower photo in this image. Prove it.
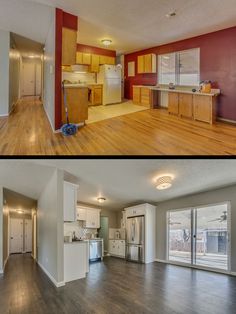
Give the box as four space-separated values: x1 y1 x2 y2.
37 170 64 286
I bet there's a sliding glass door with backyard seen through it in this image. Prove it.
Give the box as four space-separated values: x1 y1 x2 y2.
167 203 230 270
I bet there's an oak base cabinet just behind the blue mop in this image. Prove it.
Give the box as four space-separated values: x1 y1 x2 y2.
61 86 88 124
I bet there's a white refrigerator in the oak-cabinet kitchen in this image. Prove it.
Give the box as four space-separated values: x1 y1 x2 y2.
97 65 122 105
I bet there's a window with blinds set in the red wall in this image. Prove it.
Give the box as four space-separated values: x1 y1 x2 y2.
158 48 200 86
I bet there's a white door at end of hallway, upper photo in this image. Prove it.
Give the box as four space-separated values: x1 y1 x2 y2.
22 63 36 96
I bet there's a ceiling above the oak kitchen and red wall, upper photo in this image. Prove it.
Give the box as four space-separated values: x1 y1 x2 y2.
25 0 236 53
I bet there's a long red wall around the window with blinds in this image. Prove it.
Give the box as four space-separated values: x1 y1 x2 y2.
125 27 236 121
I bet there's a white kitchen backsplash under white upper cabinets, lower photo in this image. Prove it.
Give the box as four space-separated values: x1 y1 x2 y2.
64 221 97 239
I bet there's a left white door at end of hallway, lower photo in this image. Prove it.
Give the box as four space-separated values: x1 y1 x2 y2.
10 218 23 254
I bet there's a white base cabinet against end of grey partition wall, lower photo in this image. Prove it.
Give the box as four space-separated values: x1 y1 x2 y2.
64 240 89 283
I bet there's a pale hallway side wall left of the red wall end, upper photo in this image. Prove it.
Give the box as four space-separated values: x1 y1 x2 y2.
43 10 56 130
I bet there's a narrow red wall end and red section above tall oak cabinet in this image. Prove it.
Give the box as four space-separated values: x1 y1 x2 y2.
55 9 78 130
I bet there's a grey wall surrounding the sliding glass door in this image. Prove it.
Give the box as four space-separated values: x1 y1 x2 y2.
156 185 236 272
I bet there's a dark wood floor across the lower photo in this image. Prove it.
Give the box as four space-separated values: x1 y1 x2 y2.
0 255 236 314
